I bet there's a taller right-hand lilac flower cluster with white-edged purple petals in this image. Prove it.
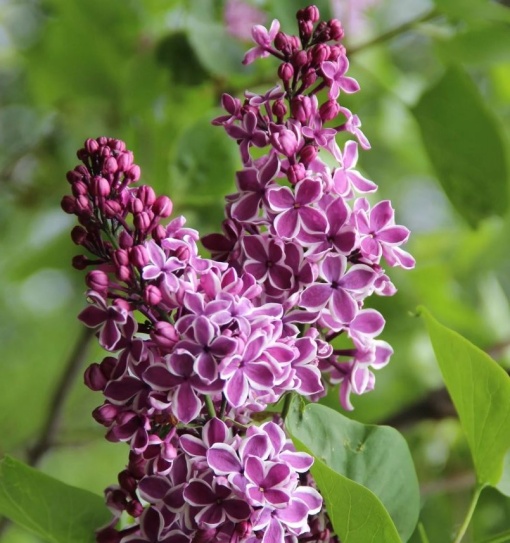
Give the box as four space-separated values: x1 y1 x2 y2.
203 6 414 409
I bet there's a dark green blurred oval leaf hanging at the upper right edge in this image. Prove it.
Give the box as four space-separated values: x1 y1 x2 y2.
413 66 509 226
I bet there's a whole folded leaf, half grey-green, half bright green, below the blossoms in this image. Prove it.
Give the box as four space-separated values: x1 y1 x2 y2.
286 401 420 542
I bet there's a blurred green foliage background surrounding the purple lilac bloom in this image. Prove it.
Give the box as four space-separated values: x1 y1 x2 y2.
0 0 510 543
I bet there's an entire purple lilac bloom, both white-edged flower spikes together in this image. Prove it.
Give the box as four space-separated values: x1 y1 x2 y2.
62 6 414 543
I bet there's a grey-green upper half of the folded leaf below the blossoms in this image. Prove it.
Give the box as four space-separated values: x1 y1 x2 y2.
286 401 420 541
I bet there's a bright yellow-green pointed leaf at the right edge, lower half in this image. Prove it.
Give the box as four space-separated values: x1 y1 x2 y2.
419 307 510 493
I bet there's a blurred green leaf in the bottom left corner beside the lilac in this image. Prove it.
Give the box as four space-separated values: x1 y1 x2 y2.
0 456 111 543
